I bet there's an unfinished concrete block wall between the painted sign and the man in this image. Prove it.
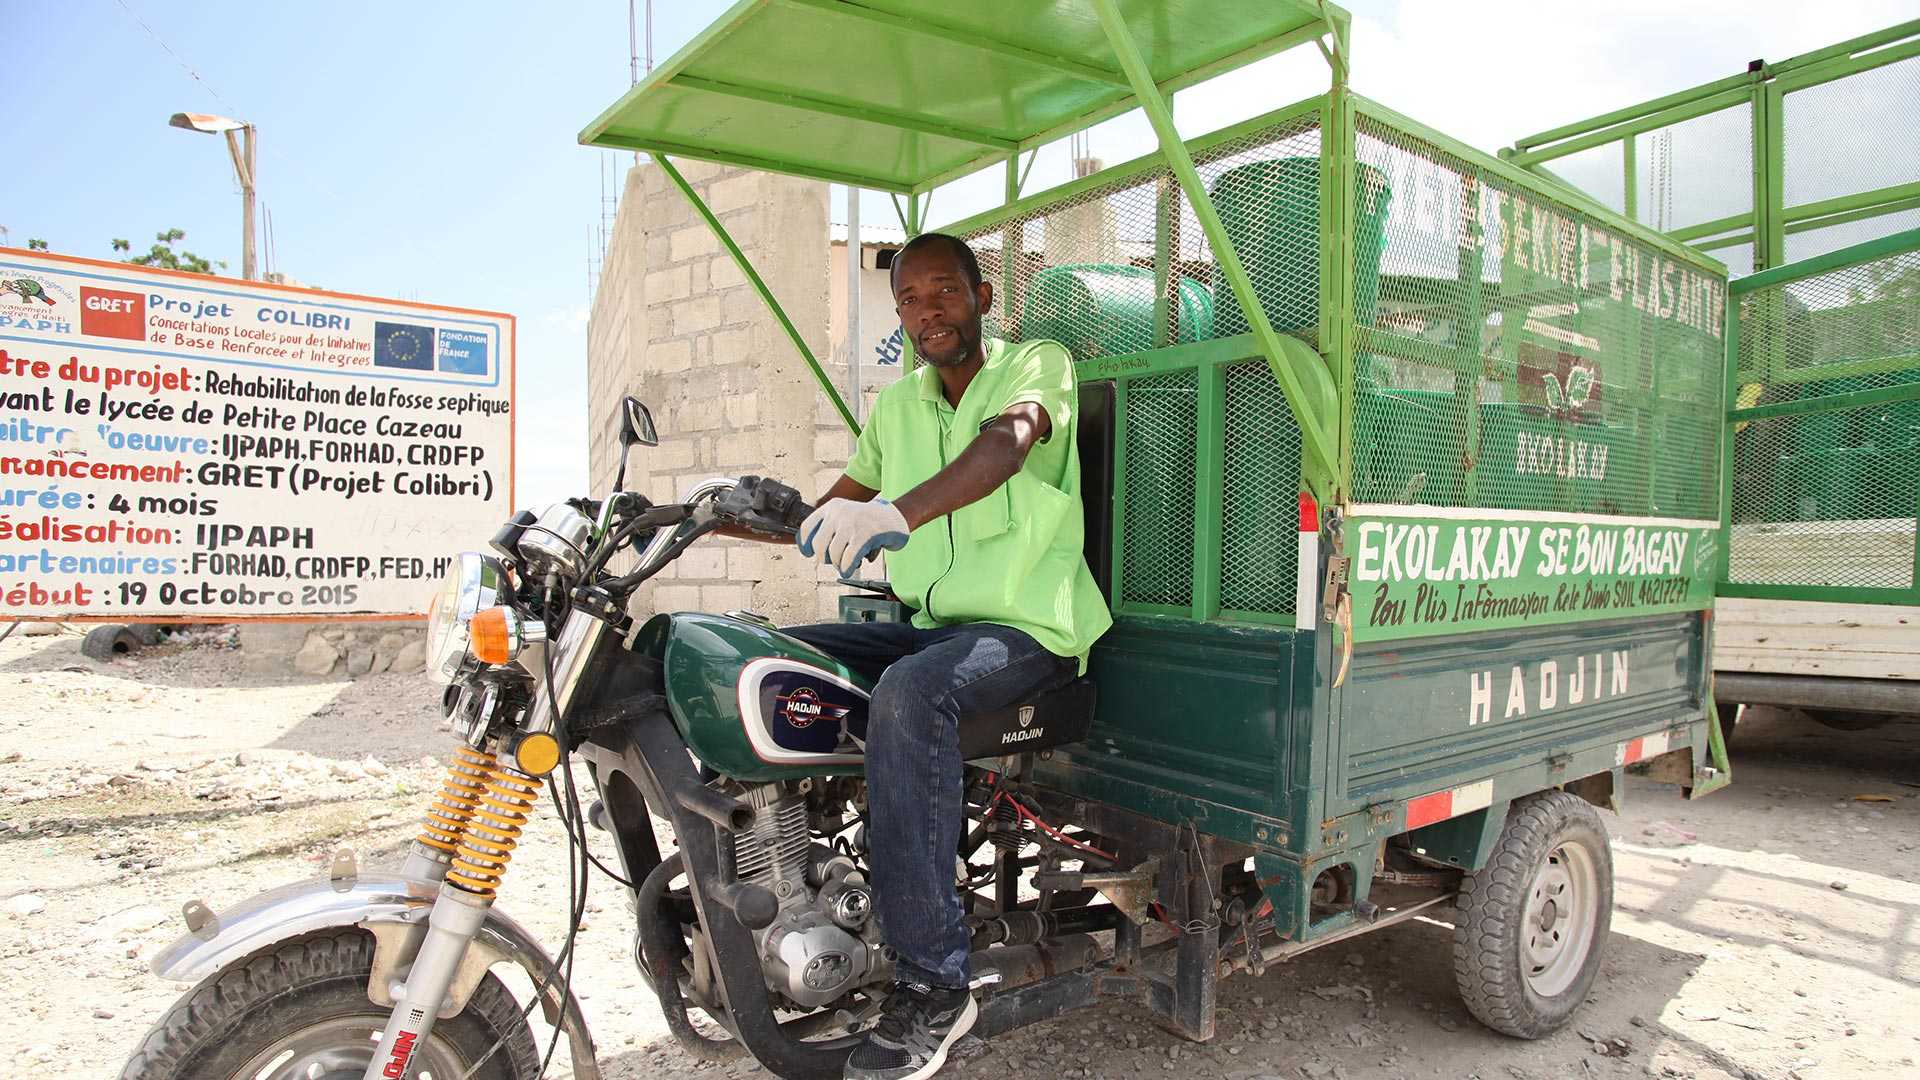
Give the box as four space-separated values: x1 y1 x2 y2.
588 161 883 623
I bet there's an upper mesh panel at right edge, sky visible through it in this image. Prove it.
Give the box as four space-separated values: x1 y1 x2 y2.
1780 56 1920 211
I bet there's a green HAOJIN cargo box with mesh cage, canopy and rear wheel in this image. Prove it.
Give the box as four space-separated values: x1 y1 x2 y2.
582 0 1730 1074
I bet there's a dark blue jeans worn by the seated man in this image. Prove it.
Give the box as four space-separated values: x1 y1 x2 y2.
785 623 1079 988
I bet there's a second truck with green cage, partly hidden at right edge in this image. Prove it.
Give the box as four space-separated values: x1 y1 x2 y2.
1501 19 1920 734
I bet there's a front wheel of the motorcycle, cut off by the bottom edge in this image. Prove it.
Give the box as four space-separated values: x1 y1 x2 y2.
121 930 540 1080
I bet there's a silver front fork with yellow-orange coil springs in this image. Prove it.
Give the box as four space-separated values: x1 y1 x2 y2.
363 748 540 1080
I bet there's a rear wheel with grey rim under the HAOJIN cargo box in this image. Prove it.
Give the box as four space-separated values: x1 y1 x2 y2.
1453 792 1613 1040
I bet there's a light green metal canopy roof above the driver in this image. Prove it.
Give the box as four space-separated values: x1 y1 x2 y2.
580 0 1348 192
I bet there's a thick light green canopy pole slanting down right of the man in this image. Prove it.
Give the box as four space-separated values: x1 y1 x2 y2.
1092 0 1340 496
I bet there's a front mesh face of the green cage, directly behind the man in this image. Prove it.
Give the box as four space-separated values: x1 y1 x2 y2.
960 113 1321 623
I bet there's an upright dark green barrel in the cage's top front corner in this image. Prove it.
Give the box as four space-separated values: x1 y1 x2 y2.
1213 158 1392 336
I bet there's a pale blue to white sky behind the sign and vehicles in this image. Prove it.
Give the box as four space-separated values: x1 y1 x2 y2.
0 0 1914 503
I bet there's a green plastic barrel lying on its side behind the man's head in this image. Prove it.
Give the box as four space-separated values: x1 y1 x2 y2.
1020 263 1213 359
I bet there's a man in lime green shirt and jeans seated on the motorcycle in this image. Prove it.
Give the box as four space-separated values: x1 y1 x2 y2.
787 233 1112 1080
